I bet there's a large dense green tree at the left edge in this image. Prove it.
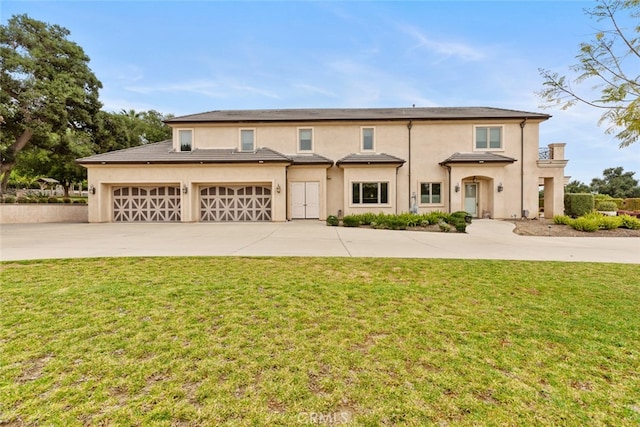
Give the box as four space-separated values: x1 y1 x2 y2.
0 15 102 193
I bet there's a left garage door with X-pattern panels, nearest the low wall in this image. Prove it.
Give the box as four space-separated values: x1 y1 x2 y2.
113 186 180 222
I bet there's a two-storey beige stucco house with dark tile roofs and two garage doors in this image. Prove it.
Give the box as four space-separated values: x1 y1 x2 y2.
78 107 567 222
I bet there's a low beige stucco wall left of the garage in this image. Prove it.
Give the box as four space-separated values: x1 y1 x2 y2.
0 203 89 224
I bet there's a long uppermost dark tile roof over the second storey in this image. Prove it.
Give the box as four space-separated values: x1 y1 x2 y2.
166 107 551 124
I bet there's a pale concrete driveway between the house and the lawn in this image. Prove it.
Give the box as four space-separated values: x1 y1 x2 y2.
0 220 640 264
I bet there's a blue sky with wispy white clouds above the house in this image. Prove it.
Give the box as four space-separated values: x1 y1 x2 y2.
0 0 640 183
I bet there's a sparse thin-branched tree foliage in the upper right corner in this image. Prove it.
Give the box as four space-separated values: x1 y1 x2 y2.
539 0 640 147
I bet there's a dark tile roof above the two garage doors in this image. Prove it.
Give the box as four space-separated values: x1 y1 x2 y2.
76 141 292 164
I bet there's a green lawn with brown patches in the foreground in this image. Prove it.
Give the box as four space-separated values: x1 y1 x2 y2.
0 258 640 426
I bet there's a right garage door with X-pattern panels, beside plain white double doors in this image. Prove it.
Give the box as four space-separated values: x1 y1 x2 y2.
200 185 271 221
